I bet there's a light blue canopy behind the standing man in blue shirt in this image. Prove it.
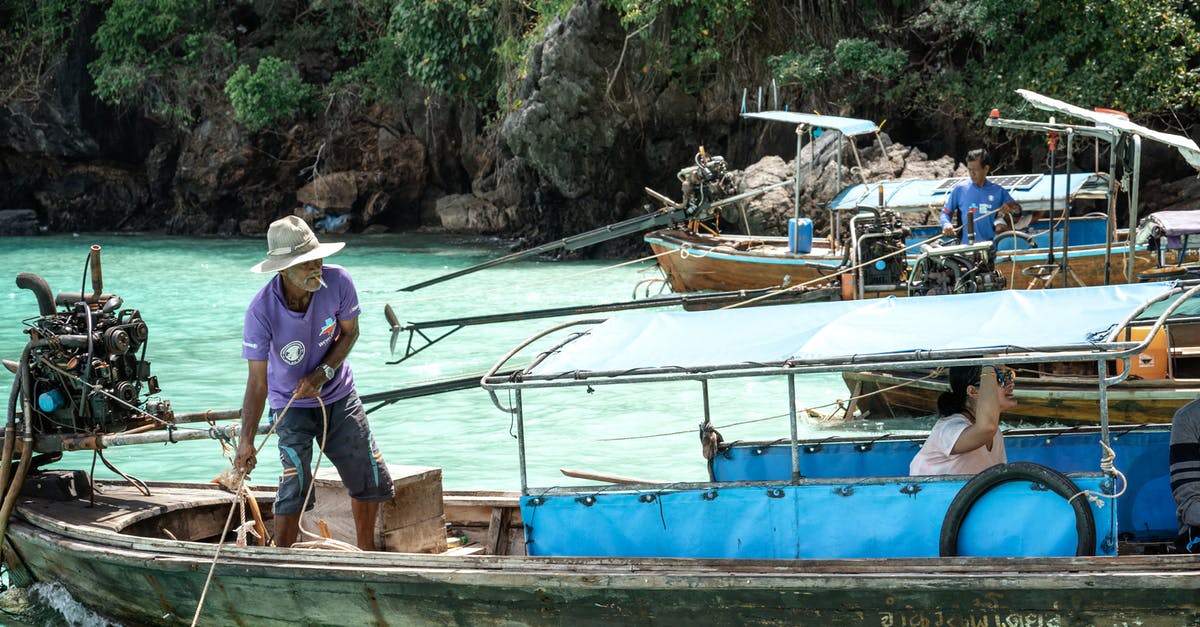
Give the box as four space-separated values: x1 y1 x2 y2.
829 172 1108 213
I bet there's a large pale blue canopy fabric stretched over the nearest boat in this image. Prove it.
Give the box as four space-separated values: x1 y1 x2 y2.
528 282 1175 377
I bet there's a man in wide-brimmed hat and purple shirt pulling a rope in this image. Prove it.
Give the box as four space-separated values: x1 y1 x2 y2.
234 216 394 550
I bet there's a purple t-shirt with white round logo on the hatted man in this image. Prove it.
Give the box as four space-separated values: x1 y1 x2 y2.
241 264 359 410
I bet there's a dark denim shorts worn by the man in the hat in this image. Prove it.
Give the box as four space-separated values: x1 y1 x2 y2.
271 392 395 514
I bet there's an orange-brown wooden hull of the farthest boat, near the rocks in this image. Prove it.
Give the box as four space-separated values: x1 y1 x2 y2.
644 229 1156 293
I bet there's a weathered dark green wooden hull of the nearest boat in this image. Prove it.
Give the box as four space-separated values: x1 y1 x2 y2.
6 486 1200 626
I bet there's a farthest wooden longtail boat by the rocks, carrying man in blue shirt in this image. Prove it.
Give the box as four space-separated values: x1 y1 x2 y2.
643 90 1200 298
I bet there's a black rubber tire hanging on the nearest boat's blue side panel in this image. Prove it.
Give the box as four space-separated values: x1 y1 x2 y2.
938 461 1096 557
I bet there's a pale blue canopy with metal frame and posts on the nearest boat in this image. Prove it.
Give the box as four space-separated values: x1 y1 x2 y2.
481 282 1200 494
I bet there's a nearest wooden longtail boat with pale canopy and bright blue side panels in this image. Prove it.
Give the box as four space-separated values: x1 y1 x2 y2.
5 283 1200 625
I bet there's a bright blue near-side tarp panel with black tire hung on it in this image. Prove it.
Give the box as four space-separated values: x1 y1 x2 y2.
521 474 1116 559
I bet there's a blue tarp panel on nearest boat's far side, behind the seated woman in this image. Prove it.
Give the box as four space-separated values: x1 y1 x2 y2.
713 425 1177 539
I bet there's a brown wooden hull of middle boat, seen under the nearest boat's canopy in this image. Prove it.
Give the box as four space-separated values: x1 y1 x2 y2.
842 371 1200 424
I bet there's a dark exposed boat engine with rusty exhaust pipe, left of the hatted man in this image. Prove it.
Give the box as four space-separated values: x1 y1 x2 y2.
10 246 172 434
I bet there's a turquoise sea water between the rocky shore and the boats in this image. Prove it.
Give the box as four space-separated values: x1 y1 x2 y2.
0 229 873 490
